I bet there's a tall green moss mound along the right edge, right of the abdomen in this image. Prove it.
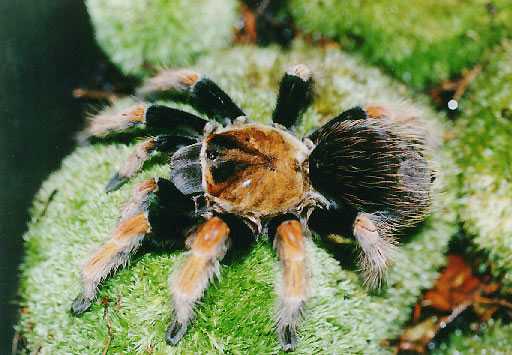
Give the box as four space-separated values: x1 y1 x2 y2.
452 42 512 286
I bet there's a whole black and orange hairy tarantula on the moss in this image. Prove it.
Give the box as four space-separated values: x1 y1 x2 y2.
71 64 433 350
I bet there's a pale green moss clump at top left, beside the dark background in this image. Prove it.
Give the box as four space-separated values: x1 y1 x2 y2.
87 0 237 76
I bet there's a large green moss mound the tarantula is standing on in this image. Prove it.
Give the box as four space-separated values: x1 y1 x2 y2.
19 44 455 354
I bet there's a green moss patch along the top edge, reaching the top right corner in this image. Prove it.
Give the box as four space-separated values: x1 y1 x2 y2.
289 0 512 89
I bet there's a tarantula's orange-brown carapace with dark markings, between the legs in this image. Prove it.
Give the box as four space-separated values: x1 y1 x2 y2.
202 124 308 217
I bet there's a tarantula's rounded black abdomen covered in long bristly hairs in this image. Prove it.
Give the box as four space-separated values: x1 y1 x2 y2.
309 105 432 230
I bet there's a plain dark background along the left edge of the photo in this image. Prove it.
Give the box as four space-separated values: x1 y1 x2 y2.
0 0 115 354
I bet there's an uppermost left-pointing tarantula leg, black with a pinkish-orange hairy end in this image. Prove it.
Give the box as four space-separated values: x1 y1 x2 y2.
137 69 245 123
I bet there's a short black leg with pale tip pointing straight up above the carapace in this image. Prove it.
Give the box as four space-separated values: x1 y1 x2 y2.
272 64 313 128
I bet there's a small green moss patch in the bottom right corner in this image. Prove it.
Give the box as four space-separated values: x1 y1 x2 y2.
433 320 512 355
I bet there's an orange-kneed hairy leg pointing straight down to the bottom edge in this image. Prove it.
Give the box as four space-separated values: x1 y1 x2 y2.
274 220 309 351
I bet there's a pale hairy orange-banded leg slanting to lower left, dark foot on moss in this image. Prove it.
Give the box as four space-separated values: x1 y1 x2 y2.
71 179 157 314
